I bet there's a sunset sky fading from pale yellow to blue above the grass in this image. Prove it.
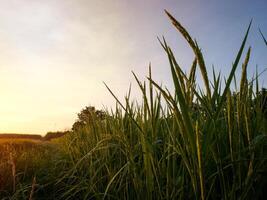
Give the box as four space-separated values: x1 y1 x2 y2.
0 0 267 134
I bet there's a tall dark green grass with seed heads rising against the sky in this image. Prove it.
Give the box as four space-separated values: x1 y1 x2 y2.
0 12 267 199
